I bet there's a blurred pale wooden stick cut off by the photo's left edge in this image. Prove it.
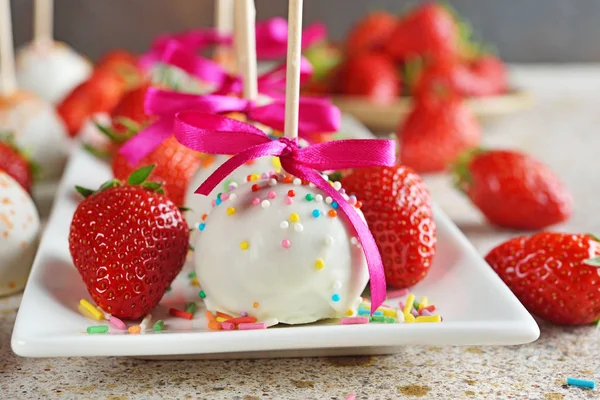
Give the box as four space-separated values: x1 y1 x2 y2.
0 0 17 96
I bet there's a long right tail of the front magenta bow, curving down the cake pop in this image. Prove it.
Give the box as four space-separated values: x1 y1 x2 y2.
281 162 386 315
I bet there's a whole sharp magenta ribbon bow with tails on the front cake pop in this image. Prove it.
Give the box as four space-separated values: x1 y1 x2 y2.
174 111 396 313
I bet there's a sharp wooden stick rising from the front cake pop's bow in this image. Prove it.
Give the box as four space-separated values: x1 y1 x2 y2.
283 0 302 139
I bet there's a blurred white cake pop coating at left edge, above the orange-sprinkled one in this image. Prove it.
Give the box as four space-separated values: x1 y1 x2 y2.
0 91 71 180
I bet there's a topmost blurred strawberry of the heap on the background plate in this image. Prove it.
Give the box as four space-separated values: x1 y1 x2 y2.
386 3 460 60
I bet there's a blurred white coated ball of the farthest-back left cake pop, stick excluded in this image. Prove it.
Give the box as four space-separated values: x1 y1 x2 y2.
16 42 93 104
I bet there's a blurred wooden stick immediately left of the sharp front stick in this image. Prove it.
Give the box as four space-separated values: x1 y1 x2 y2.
235 0 258 100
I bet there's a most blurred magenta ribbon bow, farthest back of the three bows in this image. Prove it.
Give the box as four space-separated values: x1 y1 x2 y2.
160 41 313 97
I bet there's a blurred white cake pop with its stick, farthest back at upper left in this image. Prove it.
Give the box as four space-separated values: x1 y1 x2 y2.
17 0 92 104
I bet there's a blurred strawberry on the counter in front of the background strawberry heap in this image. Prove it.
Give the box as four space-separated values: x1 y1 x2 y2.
398 94 481 172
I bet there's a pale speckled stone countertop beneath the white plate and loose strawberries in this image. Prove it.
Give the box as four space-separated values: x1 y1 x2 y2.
0 66 600 400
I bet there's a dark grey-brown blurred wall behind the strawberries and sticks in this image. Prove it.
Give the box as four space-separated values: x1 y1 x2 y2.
7 0 600 62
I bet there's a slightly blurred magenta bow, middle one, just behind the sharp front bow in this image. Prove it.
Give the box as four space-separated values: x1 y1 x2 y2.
119 87 342 166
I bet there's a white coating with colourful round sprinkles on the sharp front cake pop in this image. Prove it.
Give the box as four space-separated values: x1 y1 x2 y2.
195 175 369 324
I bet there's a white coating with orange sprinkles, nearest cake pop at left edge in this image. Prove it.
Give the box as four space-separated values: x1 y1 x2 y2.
0 172 40 296
